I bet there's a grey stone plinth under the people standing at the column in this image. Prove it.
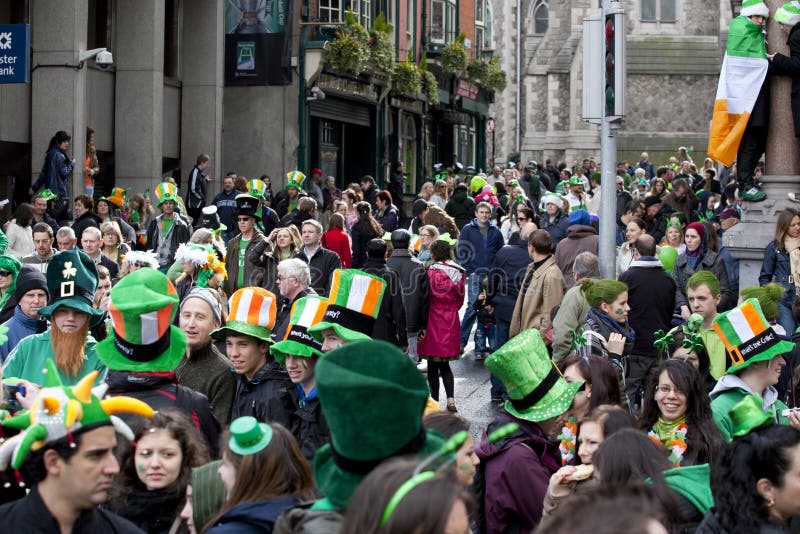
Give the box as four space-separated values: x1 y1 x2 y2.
722 175 800 289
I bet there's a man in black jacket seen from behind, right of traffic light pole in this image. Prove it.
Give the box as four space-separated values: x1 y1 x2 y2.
619 234 675 406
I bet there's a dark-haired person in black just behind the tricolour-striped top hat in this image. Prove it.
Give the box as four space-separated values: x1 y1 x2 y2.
361 239 408 349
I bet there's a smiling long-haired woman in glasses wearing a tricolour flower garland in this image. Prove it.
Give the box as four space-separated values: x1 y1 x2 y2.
639 360 725 467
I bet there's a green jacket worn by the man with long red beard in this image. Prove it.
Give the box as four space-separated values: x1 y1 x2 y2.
3 330 106 386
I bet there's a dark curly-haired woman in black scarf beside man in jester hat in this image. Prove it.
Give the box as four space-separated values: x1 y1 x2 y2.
107 408 209 533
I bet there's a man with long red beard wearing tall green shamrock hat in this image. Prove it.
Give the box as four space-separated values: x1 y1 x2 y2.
3 249 105 386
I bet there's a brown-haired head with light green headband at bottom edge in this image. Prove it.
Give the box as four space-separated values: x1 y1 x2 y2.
339 458 473 534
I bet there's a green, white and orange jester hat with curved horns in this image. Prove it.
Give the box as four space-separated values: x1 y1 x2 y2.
0 359 153 469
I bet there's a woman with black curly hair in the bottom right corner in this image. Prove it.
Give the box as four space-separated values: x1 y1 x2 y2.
696 425 800 534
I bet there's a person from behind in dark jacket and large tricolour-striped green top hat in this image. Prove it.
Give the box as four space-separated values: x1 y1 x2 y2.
101 269 221 457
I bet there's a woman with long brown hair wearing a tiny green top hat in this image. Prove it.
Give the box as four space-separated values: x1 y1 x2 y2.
203 416 315 534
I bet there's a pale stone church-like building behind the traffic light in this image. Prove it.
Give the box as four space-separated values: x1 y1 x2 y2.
487 0 733 168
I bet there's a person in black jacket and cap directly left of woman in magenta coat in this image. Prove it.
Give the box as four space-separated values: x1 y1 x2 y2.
386 230 430 361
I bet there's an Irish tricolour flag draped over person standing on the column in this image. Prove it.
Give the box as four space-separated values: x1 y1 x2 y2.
708 16 768 166
